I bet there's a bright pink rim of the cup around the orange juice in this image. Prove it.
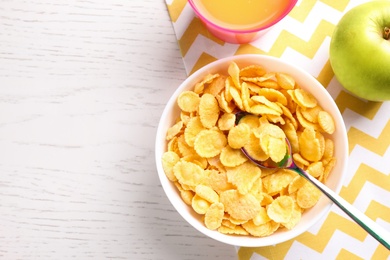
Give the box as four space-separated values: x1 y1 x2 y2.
188 0 298 33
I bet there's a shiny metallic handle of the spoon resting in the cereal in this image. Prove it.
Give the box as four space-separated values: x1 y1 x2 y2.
290 164 390 250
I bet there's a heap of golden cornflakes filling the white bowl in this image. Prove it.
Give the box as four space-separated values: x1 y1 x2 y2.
161 62 336 237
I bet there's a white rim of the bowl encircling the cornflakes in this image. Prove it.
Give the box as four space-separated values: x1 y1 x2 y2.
155 54 348 247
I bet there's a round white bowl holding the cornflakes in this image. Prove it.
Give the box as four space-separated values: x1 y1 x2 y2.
155 54 348 247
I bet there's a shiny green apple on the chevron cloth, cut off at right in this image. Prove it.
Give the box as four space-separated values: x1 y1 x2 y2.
329 0 390 101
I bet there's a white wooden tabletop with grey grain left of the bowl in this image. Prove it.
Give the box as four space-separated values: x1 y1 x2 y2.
0 0 236 259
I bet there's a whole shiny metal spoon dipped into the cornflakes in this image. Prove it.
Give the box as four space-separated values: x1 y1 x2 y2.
236 112 390 250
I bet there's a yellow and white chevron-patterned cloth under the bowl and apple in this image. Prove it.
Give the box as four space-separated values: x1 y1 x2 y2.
165 0 390 260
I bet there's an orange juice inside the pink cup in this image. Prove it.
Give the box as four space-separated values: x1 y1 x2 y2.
193 0 291 30
